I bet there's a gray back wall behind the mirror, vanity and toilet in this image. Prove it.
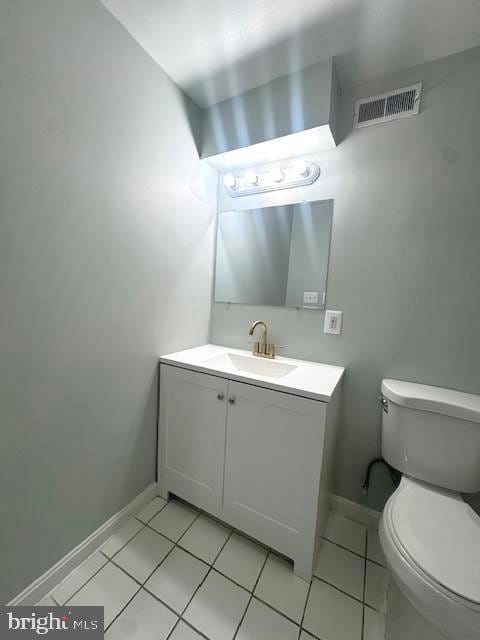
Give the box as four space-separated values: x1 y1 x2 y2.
211 48 480 508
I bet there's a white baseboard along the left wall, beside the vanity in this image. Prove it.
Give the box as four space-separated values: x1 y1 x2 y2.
8 482 157 606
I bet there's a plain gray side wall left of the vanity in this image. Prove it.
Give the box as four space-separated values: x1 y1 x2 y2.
0 0 216 602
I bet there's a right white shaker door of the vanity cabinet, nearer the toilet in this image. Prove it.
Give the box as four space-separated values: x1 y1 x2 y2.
223 382 326 564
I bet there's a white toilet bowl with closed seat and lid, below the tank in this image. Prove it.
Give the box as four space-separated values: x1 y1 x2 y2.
380 476 480 640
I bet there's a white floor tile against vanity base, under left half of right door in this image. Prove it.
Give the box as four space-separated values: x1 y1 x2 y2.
213 533 268 591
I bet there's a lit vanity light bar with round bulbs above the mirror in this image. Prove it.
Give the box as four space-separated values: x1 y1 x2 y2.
223 159 320 198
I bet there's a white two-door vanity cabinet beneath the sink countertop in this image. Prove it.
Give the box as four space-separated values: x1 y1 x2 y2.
158 348 343 580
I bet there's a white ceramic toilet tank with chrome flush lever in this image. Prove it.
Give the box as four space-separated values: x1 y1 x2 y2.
380 380 480 493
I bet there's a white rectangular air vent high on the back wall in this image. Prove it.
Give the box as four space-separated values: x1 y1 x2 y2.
353 82 422 129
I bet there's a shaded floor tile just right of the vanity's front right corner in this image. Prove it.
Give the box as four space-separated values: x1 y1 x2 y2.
314 540 365 602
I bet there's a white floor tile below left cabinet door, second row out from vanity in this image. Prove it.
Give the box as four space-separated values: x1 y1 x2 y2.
145 547 209 614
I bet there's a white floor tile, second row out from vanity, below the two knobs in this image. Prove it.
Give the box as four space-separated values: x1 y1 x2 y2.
183 571 250 640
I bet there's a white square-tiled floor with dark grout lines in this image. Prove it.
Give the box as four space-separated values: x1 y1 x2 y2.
39 498 388 640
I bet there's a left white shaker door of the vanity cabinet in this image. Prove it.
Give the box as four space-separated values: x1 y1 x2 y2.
158 365 228 514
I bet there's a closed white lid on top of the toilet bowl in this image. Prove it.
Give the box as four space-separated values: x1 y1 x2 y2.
391 479 480 604
